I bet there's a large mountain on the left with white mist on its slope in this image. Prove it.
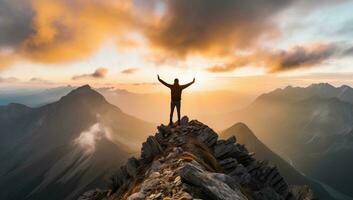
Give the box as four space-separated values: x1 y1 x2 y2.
0 85 154 200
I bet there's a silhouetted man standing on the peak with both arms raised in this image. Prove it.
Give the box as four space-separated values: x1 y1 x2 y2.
157 75 195 125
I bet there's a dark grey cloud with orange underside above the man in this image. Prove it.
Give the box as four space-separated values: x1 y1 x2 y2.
147 0 293 56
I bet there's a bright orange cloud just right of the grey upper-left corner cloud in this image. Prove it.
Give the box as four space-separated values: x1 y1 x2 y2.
21 0 132 63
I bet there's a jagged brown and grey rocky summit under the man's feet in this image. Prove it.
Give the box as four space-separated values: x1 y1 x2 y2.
79 117 315 200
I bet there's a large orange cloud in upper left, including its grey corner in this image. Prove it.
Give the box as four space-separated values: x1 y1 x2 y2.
0 0 136 66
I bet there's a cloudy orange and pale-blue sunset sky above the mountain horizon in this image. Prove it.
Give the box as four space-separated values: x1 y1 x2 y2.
0 0 353 93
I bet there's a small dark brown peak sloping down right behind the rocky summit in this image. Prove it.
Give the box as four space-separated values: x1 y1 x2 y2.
220 123 340 200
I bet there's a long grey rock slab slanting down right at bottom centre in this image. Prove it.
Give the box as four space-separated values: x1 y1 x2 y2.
179 164 247 200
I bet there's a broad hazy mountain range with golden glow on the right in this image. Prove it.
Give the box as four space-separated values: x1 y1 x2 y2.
220 84 353 197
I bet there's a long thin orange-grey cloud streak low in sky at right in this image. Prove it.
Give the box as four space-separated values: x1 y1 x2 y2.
206 43 353 73
